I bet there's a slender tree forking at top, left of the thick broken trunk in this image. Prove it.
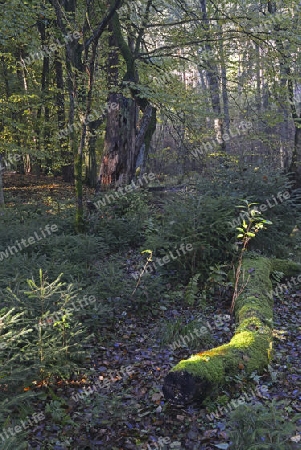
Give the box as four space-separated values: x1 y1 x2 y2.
50 0 122 231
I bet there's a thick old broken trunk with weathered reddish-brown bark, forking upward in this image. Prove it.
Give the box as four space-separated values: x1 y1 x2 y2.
99 0 156 185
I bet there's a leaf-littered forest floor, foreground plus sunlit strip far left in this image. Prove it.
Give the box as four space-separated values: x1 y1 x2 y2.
5 173 301 450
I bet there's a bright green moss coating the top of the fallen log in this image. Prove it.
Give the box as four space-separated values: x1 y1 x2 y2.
165 258 273 396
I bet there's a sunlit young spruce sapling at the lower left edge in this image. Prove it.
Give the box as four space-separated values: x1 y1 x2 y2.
0 271 89 449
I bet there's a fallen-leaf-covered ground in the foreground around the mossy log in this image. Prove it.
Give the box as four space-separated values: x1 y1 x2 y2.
24 280 301 450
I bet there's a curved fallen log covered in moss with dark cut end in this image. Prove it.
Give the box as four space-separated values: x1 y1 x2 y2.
163 257 301 403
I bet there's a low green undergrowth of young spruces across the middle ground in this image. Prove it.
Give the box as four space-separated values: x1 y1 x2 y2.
0 172 301 450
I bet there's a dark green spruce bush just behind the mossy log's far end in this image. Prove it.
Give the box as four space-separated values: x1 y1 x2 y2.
145 192 235 283
